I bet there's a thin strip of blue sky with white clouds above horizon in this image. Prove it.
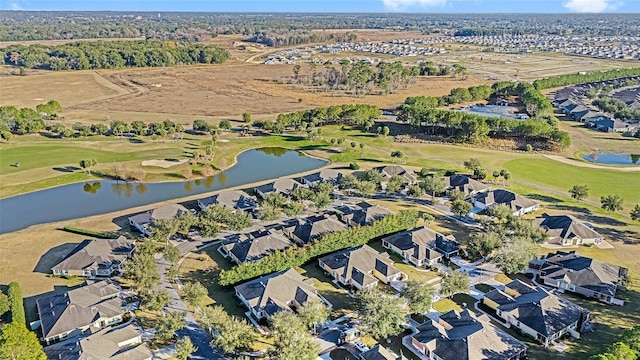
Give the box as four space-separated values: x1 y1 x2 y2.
0 0 640 13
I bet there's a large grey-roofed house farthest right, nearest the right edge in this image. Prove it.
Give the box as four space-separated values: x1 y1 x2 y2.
535 251 629 305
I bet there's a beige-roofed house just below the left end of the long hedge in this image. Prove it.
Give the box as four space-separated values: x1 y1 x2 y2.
235 269 330 320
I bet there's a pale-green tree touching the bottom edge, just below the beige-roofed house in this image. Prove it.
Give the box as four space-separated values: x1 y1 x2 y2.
269 311 320 360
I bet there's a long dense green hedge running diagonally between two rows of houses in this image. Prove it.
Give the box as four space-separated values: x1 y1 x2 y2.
218 210 418 286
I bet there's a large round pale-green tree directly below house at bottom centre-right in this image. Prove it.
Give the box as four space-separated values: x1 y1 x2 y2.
358 288 405 339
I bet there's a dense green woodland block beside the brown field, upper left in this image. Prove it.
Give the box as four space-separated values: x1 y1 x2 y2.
2 41 230 70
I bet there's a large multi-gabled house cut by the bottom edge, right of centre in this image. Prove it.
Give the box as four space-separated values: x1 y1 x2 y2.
409 309 527 360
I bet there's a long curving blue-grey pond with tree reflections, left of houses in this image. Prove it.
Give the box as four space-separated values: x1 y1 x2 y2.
0 148 327 233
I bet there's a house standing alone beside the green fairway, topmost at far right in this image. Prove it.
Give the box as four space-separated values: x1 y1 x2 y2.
534 214 604 246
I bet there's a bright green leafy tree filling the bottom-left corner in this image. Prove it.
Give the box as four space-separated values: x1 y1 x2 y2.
0 322 47 360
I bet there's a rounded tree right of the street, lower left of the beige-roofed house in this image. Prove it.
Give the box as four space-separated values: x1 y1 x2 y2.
211 312 256 354
